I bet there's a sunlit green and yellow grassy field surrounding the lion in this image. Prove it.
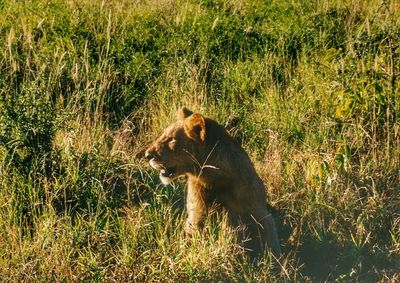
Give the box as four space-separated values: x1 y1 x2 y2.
0 0 400 282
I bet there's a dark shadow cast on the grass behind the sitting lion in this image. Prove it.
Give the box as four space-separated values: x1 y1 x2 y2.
275 216 400 282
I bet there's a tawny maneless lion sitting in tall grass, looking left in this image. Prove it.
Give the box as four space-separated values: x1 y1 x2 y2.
145 108 281 258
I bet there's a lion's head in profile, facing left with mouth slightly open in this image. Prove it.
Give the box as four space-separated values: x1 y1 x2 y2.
145 108 206 185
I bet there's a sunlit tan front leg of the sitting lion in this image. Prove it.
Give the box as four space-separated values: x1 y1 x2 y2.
185 180 207 237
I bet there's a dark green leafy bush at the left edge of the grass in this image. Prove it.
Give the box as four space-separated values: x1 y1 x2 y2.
0 89 56 176
